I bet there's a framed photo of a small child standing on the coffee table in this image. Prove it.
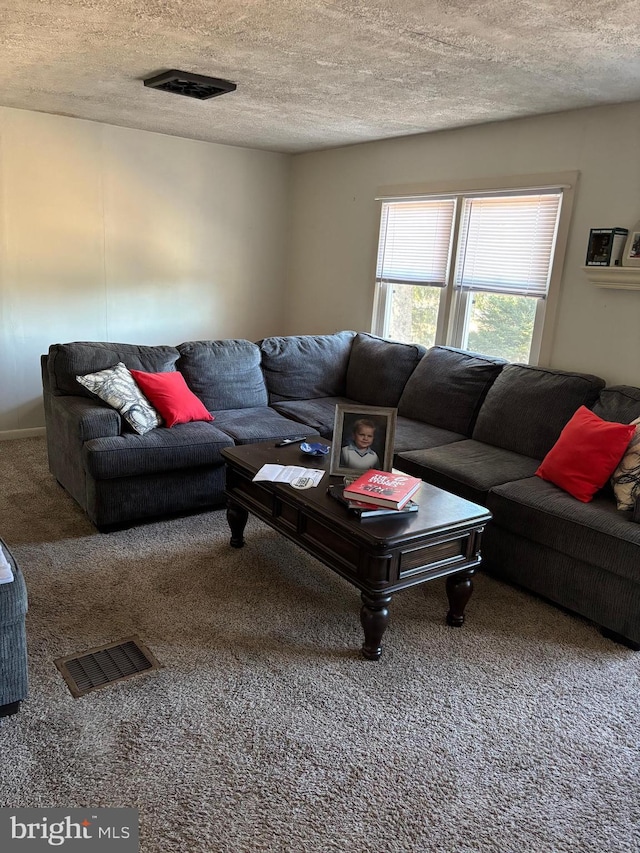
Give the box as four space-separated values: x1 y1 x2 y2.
329 403 398 477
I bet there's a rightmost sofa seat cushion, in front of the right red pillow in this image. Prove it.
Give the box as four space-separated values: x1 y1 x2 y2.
487 477 640 582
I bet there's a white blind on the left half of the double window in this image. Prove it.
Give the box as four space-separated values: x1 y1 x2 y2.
376 198 456 287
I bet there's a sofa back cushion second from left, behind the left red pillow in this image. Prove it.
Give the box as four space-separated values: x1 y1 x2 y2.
177 339 267 412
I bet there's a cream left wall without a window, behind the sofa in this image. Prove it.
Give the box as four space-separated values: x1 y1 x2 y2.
0 108 291 437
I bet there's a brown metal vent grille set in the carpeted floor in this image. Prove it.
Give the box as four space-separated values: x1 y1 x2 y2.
54 637 161 699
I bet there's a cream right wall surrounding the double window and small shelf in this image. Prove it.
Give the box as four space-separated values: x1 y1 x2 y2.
287 103 640 385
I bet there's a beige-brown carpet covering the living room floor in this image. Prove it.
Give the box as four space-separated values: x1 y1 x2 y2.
0 439 640 853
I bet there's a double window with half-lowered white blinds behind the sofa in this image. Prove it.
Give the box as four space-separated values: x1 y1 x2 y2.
373 175 576 363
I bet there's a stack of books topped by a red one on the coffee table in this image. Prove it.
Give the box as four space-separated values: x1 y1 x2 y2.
329 468 422 518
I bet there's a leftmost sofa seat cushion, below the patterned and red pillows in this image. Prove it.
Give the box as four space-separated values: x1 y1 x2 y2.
82 421 233 480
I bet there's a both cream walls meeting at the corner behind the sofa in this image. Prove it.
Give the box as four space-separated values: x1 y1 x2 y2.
5 104 640 438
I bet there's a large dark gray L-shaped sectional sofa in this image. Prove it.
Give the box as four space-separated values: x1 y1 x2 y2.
42 331 640 647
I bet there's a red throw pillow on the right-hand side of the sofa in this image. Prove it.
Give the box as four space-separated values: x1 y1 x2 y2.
536 406 636 503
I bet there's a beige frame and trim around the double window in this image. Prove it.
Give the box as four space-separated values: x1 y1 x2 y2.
371 171 579 366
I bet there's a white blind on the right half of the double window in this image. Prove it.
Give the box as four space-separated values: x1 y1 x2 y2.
456 191 562 297
